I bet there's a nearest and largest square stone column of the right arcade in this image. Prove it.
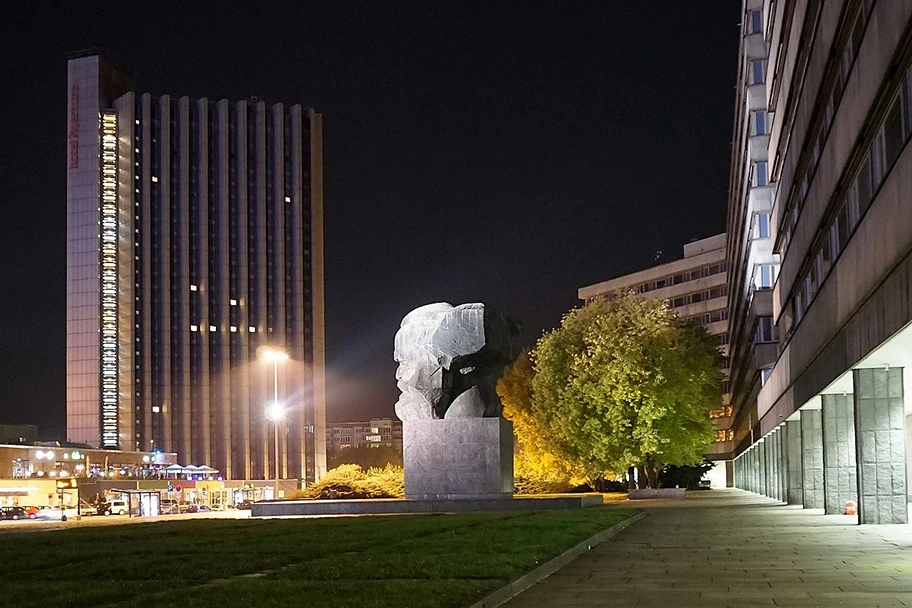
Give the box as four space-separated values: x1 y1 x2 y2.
852 367 909 524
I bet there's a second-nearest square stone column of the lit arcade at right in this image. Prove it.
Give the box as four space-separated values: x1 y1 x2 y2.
821 395 858 514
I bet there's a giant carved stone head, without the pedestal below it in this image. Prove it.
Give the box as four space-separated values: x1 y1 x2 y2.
394 302 520 420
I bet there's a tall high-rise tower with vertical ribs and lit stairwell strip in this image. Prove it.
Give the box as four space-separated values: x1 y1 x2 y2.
66 53 326 480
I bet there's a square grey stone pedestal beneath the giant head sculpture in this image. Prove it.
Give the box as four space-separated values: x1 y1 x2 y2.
402 417 513 500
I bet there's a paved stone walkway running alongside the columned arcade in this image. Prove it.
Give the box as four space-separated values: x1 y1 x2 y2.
504 490 912 608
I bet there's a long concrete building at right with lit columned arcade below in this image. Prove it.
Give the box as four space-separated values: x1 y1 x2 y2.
728 0 912 523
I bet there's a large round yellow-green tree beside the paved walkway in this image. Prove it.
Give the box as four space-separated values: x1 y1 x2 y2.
532 293 722 488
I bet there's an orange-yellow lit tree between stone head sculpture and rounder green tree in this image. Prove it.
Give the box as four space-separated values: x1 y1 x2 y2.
497 350 582 492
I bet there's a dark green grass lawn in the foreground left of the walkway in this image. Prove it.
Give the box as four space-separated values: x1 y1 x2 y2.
0 506 636 608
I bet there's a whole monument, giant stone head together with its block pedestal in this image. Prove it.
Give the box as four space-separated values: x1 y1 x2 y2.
395 303 520 500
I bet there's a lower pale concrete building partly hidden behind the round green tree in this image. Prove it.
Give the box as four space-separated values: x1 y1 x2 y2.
578 234 732 485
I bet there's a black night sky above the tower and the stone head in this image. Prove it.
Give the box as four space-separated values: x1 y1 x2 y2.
0 2 739 438
